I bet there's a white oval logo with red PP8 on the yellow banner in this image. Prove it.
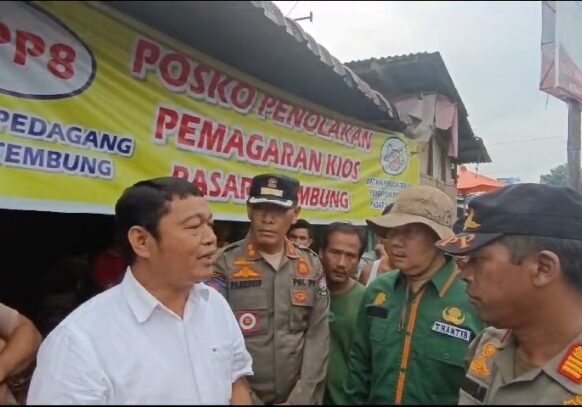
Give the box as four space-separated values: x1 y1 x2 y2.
0 1 97 99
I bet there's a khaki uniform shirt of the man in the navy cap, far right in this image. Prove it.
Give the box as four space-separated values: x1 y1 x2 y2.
459 328 582 405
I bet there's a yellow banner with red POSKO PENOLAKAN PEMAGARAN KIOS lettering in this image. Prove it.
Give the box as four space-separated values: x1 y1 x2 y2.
0 1 419 224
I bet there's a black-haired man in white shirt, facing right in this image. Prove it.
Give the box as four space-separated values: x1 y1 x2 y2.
27 177 253 404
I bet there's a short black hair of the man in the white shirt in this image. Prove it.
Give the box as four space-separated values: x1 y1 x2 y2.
115 177 204 265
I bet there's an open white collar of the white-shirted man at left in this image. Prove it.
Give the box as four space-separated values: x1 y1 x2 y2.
121 267 210 324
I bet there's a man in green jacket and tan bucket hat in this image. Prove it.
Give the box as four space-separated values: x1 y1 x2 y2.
344 186 485 404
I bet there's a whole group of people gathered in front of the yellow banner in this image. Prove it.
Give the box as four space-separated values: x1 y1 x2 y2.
0 174 582 405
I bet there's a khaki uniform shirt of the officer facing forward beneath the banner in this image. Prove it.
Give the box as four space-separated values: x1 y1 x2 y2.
209 236 329 404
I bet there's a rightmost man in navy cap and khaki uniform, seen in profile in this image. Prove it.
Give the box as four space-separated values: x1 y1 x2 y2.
437 184 582 405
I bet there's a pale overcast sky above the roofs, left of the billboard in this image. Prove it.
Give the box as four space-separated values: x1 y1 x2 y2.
274 1 567 182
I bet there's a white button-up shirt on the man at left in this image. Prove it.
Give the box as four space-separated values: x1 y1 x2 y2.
27 269 253 404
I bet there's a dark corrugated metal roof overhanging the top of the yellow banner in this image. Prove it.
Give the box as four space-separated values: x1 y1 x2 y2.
105 0 405 131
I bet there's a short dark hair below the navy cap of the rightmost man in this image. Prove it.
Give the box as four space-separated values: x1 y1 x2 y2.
499 235 582 293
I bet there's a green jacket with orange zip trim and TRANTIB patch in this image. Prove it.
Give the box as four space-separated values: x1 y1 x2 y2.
344 260 485 405
